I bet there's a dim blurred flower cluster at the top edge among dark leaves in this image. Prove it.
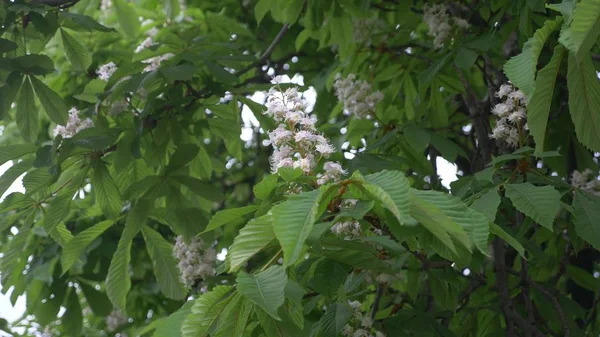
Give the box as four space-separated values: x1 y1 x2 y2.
423 4 470 49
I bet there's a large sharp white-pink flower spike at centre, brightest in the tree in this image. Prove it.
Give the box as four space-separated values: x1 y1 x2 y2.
263 77 346 184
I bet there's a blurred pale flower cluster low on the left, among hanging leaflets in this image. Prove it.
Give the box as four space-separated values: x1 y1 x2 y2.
173 236 217 287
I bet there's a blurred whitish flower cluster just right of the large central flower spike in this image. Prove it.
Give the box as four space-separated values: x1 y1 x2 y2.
333 73 383 118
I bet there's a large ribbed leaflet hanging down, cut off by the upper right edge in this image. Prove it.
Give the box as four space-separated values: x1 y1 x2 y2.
567 55 600 152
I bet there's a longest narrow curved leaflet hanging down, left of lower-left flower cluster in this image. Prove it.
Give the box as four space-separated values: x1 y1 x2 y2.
106 200 152 311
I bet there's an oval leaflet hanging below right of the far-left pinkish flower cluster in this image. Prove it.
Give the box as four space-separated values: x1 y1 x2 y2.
92 159 123 219
